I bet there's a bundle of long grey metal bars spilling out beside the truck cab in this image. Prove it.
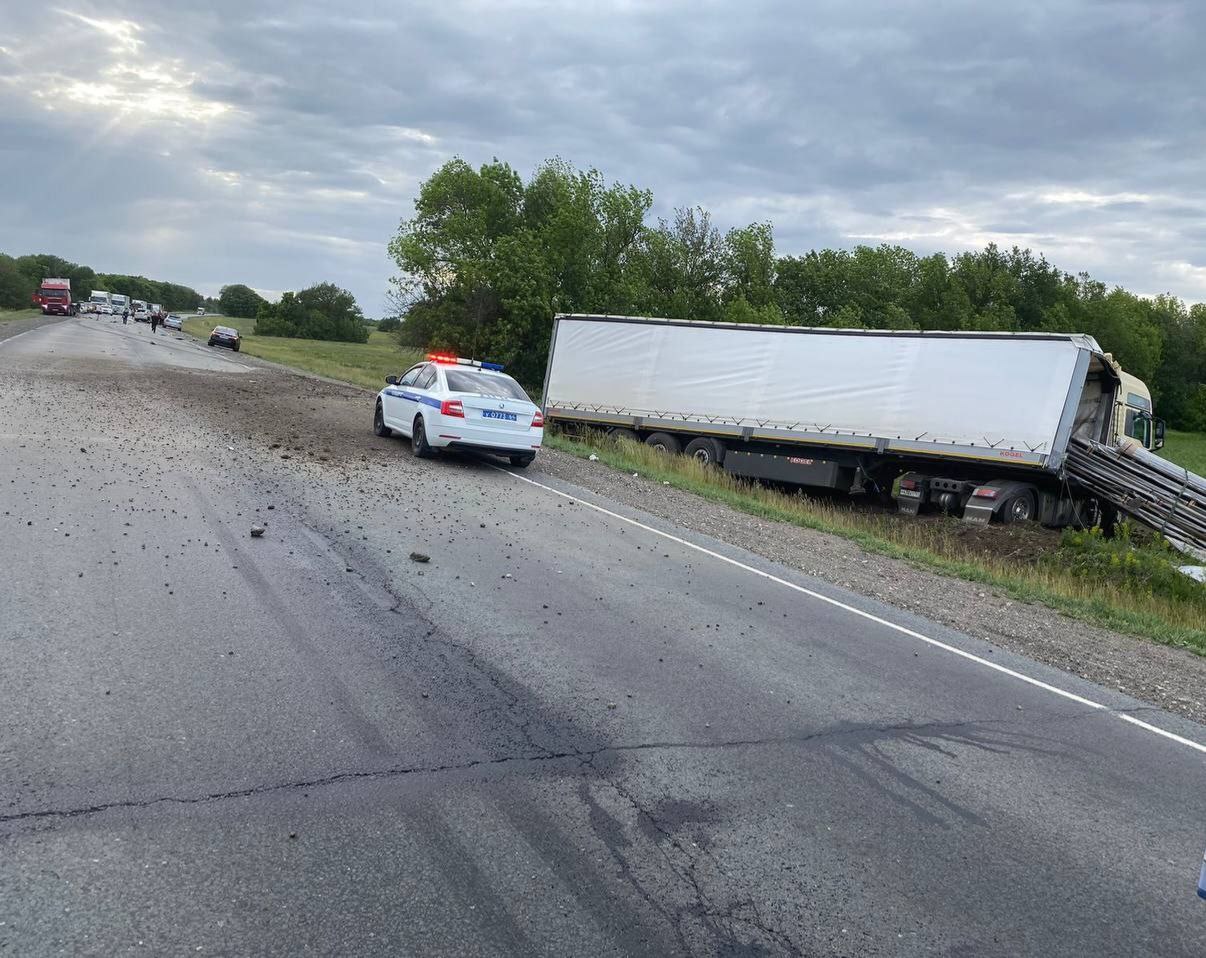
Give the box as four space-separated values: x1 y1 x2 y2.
1064 439 1206 561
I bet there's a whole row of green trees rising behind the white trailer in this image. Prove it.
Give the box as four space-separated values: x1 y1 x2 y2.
390 159 1206 430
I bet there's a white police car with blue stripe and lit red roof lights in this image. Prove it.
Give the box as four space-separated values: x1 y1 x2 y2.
373 354 544 468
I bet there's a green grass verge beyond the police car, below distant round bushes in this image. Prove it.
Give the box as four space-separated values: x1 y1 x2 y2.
185 316 422 390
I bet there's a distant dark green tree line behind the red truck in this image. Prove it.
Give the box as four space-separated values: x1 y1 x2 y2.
0 253 205 311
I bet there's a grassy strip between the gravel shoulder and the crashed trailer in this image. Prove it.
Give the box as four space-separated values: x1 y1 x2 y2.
545 433 1206 655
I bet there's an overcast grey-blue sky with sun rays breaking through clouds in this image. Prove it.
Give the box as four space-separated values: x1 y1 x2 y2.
0 0 1206 316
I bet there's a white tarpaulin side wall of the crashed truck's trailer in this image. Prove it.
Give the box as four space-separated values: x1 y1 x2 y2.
545 316 1097 456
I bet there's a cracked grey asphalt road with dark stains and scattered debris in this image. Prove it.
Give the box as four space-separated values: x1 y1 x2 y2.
0 317 1206 956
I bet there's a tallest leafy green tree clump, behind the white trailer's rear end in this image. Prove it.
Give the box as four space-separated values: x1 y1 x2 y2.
390 159 652 381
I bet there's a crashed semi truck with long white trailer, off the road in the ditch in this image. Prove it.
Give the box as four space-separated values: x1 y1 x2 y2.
543 315 1164 526
